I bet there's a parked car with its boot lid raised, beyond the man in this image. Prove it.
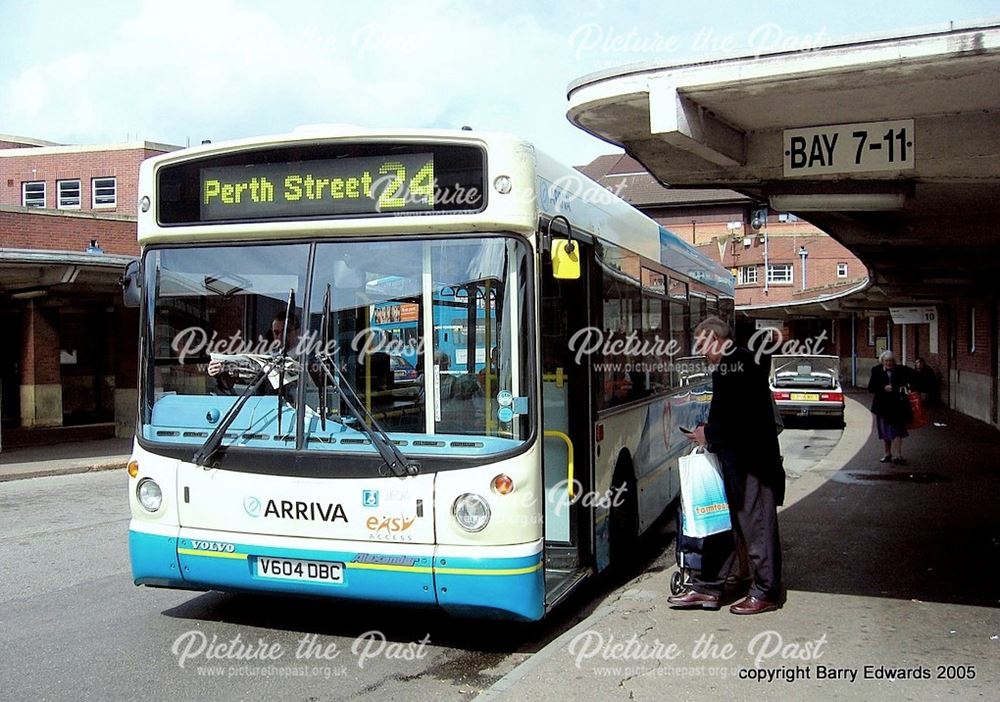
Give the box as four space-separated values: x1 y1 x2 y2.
770 355 844 422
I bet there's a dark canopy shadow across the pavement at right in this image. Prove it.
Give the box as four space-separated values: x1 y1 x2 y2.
780 397 1000 607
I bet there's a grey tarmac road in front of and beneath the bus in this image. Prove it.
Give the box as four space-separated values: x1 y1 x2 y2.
0 429 839 702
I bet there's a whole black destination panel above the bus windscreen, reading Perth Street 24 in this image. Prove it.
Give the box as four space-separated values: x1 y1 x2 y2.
156 141 487 226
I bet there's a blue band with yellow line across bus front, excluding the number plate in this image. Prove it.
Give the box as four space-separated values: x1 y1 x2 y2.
129 531 545 620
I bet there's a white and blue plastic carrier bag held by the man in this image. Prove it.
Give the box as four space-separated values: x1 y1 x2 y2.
680 447 732 538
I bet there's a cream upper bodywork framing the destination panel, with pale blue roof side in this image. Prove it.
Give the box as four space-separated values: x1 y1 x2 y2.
139 124 733 297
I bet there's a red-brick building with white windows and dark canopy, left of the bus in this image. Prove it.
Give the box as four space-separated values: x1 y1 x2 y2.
0 135 176 446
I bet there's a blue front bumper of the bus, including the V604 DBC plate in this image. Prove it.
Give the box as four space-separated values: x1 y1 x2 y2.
129 523 545 621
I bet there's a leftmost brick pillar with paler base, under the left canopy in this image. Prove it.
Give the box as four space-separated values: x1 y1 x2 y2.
21 300 62 429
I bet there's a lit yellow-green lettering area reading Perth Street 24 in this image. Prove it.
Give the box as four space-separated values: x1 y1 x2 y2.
201 153 435 221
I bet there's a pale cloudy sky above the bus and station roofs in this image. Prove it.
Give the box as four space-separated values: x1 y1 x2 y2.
0 0 1000 165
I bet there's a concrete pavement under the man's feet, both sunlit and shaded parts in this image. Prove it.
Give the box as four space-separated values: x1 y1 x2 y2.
480 395 1000 702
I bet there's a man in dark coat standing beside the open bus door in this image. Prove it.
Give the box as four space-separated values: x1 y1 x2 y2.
668 317 785 614
